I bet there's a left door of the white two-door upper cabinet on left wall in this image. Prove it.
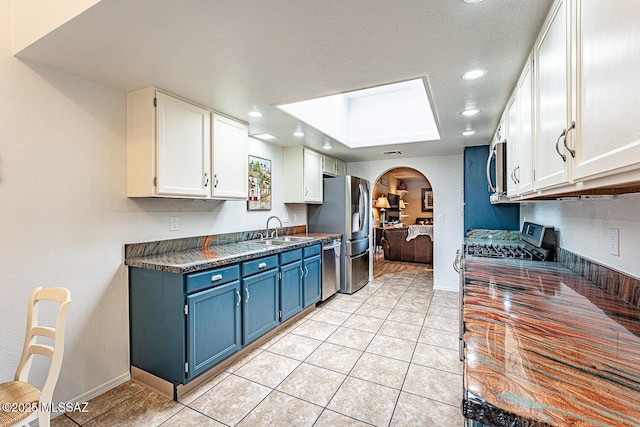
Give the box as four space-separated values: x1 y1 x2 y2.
156 92 211 198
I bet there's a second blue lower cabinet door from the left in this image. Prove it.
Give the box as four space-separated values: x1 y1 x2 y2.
242 268 279 345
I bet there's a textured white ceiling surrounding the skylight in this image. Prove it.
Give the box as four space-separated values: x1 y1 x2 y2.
17 0 552 161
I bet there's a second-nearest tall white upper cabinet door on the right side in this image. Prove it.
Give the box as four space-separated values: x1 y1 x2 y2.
534 0 571 190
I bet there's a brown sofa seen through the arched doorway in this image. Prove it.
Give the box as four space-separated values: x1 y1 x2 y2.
380 228 433 264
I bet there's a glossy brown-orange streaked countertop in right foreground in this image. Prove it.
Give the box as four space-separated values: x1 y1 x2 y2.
463 258 640 426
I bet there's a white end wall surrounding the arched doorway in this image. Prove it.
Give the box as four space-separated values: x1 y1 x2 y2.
347 155 464 291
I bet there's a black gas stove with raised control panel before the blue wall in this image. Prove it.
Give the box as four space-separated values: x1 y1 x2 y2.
464 222 556 261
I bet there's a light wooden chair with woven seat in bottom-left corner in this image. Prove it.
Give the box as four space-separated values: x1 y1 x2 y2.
0 288 71 427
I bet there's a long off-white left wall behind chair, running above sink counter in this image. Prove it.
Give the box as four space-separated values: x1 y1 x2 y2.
0 0 306 401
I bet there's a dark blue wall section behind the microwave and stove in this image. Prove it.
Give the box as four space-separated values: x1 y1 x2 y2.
464 145 520 233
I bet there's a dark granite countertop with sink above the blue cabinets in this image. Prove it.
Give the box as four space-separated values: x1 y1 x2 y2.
125 233 341 274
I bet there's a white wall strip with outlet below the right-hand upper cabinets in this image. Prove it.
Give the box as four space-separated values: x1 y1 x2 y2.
520 194 640 277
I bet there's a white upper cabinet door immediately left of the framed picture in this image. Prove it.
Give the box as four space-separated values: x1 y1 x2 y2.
212 114 249 200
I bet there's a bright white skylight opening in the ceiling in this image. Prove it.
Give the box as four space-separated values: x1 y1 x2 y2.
278 78 440 148
